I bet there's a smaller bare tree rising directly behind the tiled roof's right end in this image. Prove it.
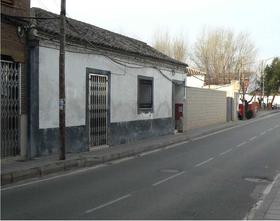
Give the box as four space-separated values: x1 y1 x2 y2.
153 31 187 62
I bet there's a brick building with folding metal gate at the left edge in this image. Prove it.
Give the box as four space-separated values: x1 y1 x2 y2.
0 0 30 158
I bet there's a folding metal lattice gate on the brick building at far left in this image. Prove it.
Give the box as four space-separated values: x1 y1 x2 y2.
1 61 21 158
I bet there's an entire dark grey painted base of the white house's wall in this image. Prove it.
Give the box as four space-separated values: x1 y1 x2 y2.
32 118 173 157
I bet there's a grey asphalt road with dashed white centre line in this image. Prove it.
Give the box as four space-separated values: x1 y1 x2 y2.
1 113 280 219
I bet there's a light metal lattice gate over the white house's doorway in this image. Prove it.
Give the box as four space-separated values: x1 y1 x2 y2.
88 74 108 147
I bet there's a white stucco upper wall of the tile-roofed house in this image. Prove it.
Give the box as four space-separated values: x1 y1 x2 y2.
39 46 185 128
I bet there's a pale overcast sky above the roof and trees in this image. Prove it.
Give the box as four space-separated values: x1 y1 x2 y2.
31 0 280 61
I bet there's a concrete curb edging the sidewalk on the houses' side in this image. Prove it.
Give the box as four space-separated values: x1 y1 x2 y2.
1 112 278 186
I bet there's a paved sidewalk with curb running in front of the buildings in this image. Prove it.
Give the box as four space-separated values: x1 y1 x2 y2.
1 111 279 185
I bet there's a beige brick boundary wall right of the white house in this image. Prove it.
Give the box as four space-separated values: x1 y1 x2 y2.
184 87 227 131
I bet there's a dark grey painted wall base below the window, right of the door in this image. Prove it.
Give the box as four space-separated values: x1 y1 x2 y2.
109 118 174 145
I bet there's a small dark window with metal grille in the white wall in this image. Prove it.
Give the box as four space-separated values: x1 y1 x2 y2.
138 76 153 113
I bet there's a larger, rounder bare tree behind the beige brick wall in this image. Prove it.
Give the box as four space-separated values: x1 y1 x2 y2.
191 29 256 84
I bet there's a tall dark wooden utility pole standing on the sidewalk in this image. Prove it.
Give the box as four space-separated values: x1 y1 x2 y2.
59 0 66 160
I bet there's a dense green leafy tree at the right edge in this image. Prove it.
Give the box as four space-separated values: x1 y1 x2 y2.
264 57 280 104
